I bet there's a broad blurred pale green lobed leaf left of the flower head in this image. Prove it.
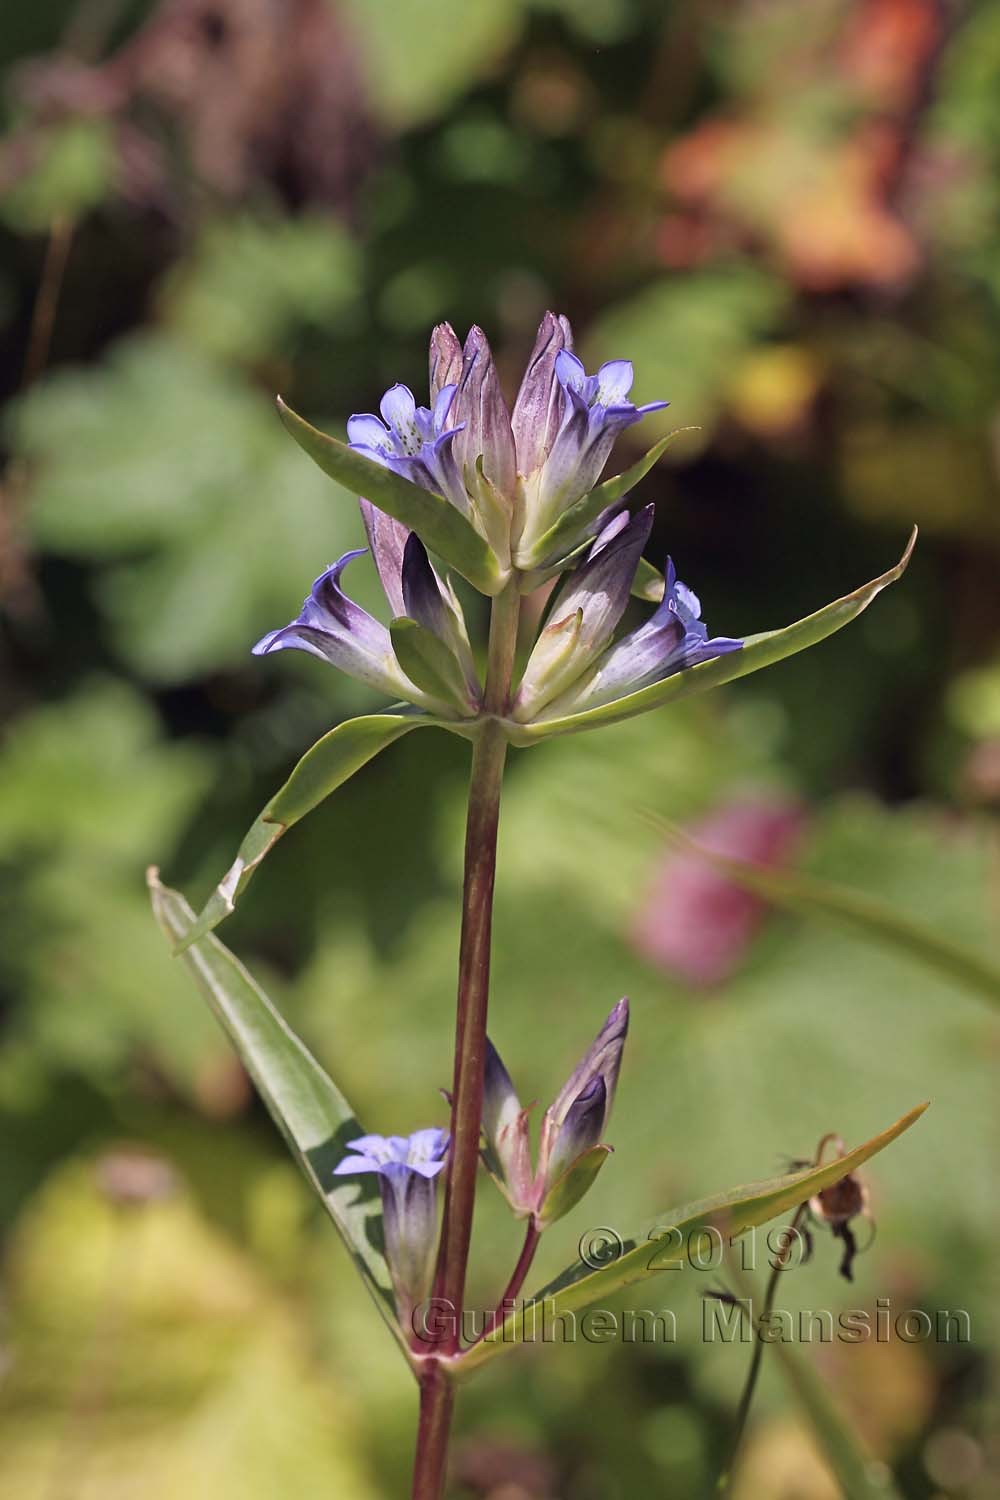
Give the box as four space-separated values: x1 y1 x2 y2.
10 329 365 687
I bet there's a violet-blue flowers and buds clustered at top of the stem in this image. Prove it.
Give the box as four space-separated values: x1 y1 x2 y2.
255 314 742 725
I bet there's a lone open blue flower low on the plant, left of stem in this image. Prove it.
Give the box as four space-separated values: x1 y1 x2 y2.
334 1128 448 1328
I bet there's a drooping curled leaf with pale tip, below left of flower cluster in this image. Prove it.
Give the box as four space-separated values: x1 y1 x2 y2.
177 711 456 953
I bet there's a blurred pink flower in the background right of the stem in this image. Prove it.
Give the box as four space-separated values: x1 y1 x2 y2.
631 797 807 986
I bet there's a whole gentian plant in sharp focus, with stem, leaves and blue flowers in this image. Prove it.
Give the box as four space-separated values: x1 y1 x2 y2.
150 314 919 1500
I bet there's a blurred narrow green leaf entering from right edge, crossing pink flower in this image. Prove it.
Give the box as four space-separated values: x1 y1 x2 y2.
657 819 1000 1005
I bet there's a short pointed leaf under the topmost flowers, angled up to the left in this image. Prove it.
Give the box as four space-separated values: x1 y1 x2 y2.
277 398 505 596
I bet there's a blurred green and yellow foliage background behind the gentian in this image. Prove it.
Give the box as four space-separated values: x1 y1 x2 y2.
0 0 1000 1500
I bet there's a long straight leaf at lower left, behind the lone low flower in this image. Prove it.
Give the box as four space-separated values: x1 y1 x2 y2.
147 870 405 1349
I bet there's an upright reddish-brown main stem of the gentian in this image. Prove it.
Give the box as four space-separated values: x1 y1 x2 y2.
412 578 520 1500
